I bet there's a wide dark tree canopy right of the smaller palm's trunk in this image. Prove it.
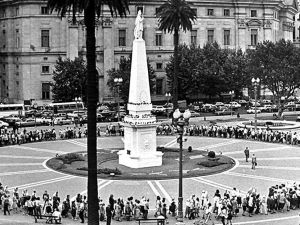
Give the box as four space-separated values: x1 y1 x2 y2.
166 42 247 99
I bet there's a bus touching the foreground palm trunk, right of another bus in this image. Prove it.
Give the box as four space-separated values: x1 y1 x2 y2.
48 102 85 114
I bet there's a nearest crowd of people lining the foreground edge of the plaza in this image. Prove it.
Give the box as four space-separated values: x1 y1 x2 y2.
0 182 300 225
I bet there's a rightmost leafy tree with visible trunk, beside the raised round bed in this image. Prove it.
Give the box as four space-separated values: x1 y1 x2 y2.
248 39 300 116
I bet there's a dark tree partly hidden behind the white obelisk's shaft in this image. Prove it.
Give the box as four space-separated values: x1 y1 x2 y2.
107 57 156 102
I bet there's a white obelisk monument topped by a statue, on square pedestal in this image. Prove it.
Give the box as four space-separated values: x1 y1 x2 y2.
118 11 163 168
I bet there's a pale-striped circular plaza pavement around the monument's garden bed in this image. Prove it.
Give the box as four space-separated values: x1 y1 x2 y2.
0 136 300 225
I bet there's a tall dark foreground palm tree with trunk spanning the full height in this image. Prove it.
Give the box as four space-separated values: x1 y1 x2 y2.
48 0 129 224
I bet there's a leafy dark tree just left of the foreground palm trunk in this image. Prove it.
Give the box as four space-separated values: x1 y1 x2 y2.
52 57 87 102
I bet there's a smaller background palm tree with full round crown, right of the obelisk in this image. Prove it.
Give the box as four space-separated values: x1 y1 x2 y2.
156 0 197 109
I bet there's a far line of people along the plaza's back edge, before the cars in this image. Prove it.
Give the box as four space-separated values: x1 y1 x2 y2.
0 118 300 146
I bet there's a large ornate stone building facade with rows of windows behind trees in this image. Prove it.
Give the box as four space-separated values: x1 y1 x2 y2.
0 0 298 104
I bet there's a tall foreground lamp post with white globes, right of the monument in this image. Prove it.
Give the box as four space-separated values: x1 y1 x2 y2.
173 109 191 222
